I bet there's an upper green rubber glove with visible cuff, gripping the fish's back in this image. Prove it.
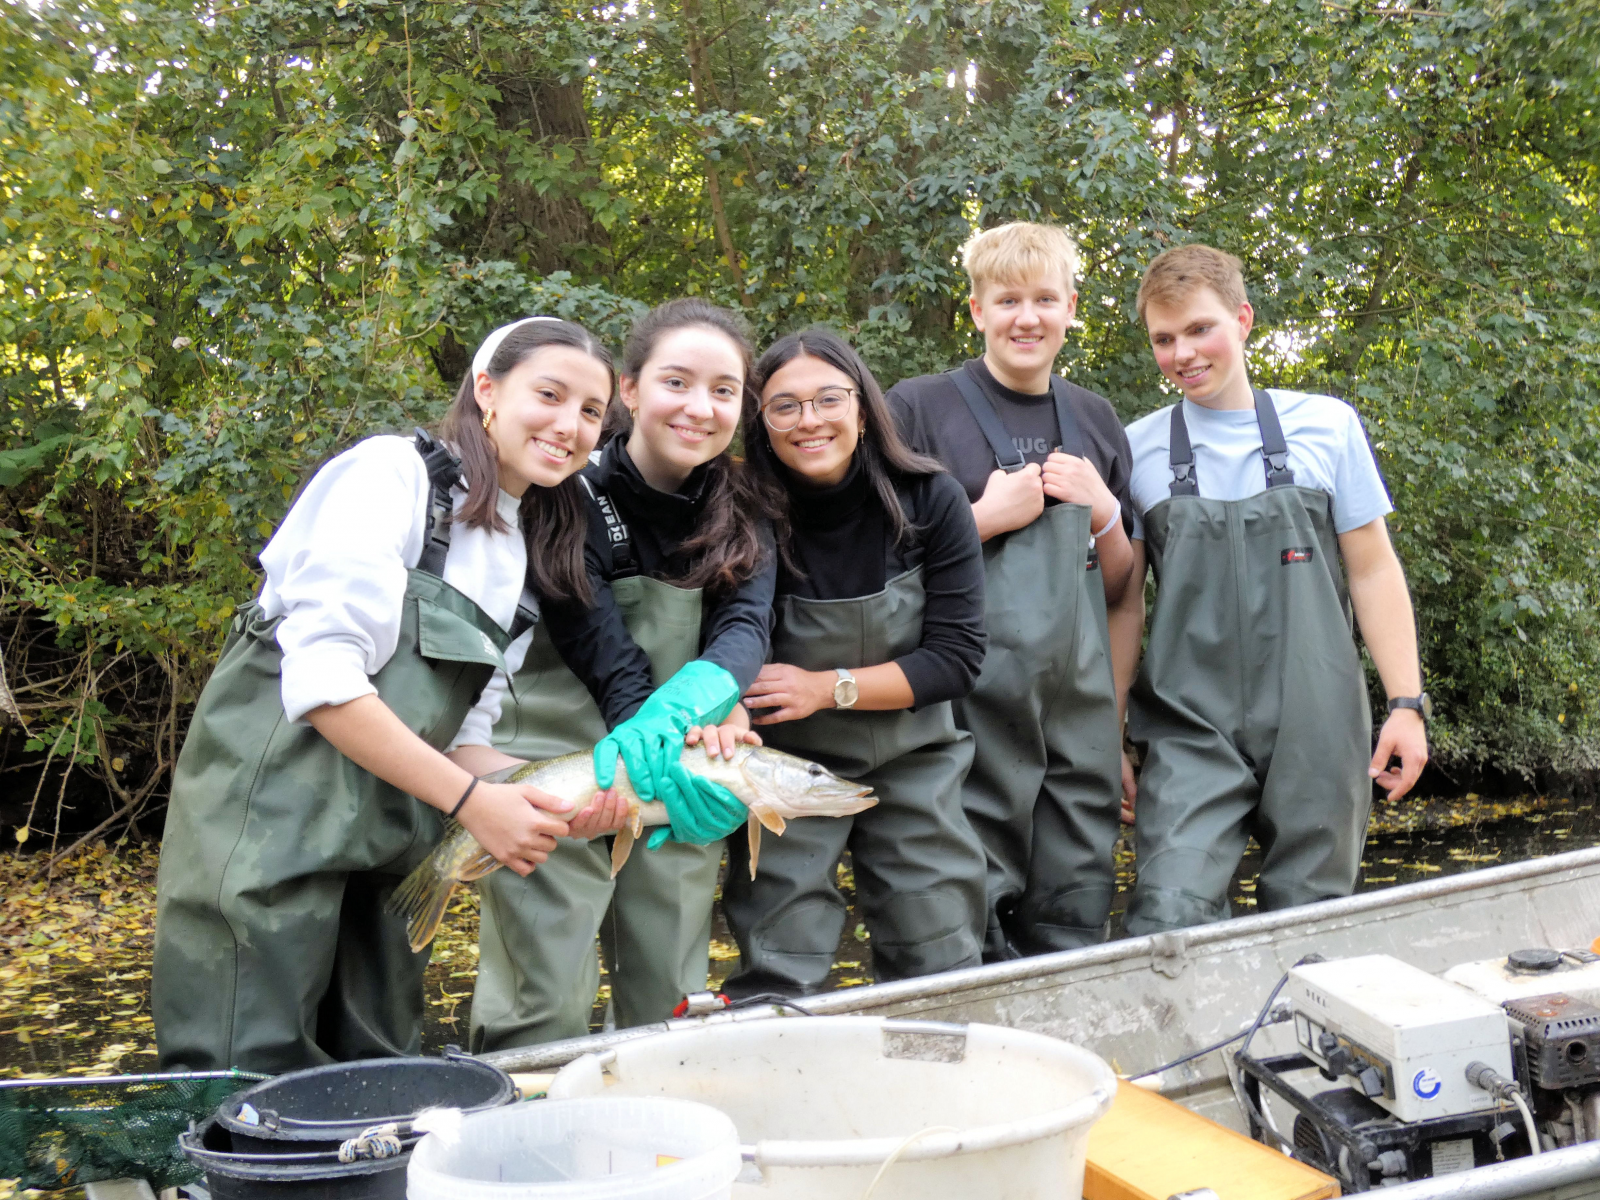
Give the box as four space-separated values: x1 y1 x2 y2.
595 659 739 803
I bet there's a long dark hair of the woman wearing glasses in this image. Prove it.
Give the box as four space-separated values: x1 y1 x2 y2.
744 326 944 574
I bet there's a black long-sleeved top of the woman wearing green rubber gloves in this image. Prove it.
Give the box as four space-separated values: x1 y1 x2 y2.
544 437 778 728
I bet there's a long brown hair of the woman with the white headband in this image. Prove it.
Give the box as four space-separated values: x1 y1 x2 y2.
438 320 621 603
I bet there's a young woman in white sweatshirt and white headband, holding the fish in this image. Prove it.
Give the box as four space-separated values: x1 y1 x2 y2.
152 318 621 1074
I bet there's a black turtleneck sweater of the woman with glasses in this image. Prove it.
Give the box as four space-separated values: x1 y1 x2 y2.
778 459 987 709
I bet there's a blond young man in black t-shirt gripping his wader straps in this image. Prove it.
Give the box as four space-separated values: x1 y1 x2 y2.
888 222 1138 962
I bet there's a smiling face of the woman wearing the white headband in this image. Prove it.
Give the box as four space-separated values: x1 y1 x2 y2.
477 346 611 496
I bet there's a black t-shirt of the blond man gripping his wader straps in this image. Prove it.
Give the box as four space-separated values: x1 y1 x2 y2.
888 358 1133 533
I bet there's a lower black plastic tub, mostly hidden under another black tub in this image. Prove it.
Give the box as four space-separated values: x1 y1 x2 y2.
178 1117 411 1200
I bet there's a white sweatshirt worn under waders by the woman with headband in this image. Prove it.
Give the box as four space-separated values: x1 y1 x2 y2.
259 437 531 749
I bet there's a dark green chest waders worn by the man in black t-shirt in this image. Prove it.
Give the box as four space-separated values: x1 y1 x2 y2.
950 368 1122 962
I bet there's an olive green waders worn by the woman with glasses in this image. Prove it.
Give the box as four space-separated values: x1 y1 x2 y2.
722 566 984 998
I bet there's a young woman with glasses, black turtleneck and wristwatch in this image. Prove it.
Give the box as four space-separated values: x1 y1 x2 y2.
723 330 984 998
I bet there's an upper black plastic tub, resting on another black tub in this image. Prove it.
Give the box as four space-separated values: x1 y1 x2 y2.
216 1051 517 1154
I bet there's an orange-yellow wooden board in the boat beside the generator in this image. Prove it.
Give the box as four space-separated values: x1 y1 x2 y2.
1083 1083 1339 1200
